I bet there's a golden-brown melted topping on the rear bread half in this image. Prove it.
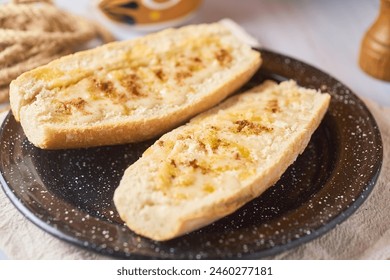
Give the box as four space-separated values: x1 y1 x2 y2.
35 36 234 124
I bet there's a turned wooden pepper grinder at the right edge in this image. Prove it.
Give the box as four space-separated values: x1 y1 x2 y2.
359 0 390 81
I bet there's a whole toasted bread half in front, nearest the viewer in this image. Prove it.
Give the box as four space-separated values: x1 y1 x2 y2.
114 81 330 241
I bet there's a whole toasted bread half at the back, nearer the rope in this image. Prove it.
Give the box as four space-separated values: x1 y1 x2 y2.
10 23 261 149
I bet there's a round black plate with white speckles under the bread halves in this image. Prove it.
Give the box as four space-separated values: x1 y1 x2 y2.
0 50 382 259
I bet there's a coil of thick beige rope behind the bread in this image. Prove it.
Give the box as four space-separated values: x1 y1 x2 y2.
0 0 114 102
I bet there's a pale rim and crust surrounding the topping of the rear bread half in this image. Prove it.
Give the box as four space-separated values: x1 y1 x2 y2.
10 24 261 149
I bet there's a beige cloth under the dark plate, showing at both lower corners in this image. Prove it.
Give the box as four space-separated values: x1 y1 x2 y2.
0 97 390 259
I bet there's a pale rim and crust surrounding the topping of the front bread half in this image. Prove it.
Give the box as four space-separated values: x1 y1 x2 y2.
114 81 330 241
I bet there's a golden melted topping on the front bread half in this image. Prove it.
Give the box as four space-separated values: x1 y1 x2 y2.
145 83 320 201
